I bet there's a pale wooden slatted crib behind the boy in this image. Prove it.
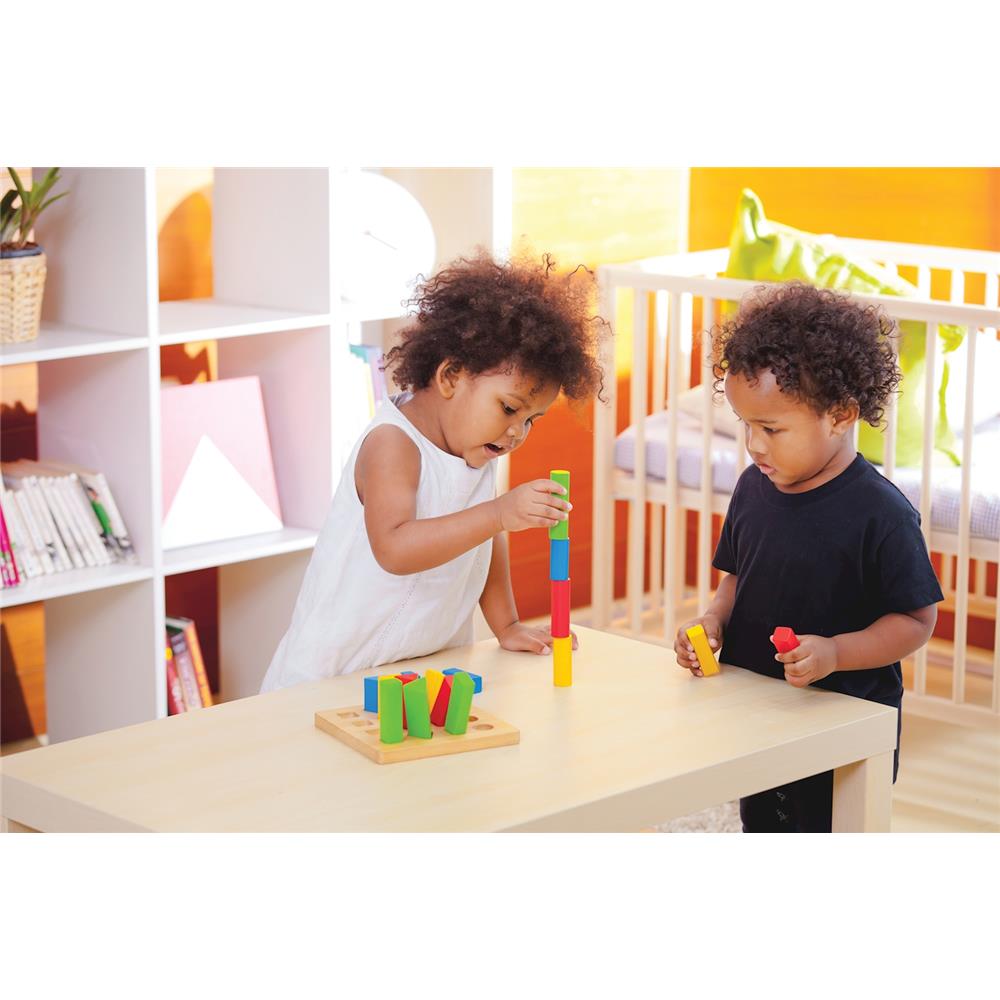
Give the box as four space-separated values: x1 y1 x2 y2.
592 239 1000 726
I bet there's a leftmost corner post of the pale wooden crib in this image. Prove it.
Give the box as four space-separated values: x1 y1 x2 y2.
590 279 618 628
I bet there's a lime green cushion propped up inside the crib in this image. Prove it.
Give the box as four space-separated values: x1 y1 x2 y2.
726 188 965 466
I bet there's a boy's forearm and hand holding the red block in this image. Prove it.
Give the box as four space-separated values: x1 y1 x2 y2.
775 604 937 687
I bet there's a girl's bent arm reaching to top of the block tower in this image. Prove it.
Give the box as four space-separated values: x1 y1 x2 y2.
354 425 568 576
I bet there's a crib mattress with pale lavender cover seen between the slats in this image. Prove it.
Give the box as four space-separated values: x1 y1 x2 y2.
615 410 1000 540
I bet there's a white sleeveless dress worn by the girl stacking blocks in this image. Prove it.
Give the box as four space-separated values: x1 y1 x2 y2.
261 393 496 692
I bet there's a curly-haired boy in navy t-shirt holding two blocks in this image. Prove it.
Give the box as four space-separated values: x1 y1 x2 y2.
674 284 943 833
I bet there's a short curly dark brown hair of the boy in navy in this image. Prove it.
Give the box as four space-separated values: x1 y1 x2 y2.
712 281 900 427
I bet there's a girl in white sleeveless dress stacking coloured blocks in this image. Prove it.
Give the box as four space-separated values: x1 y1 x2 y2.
261 252 606 691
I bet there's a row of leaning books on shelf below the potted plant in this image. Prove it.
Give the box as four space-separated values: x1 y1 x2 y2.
0 459 135 587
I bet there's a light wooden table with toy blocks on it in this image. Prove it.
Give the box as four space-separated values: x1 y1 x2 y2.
0 628 896 831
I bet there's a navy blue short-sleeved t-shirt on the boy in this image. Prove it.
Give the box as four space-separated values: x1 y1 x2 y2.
712 455 944 708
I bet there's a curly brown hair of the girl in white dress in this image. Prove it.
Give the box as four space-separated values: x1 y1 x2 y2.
384 250 608 402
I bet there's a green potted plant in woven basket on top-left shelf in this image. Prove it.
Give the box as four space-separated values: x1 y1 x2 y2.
0 167 69 344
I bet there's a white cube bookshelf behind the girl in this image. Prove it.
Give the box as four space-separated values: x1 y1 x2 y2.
0 168 511 742
